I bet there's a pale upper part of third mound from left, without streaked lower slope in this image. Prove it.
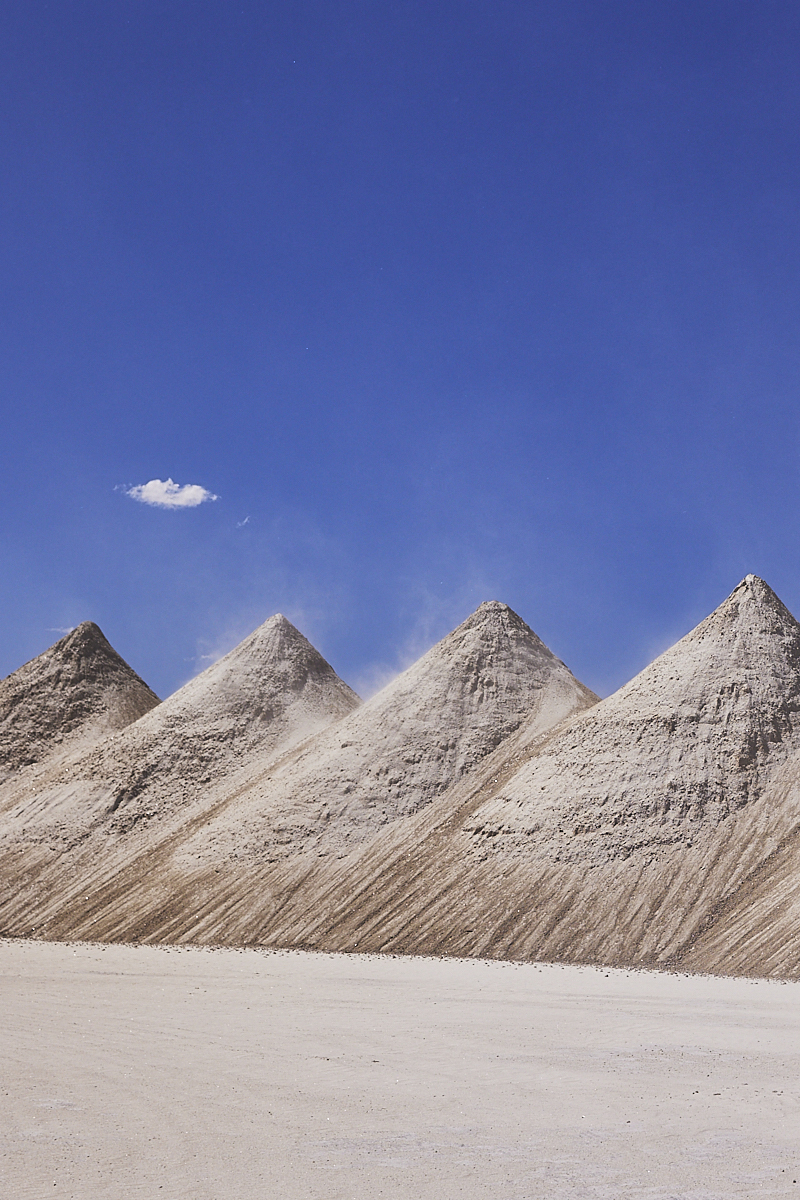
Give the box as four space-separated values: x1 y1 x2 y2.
173 601 597 862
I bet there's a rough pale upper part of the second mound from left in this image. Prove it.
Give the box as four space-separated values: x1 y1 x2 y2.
0 614 359 845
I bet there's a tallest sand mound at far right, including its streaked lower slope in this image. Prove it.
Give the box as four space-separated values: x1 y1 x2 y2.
241 576 800 974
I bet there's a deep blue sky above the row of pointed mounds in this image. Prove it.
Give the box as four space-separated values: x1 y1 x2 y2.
0 0 800 696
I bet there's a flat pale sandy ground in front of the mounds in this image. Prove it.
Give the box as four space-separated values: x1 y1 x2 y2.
0 942 800 1200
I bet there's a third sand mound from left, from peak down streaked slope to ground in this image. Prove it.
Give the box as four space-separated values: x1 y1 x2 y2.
0 602 596 942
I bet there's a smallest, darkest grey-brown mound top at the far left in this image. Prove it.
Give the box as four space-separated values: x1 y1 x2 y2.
0 620 158 780
